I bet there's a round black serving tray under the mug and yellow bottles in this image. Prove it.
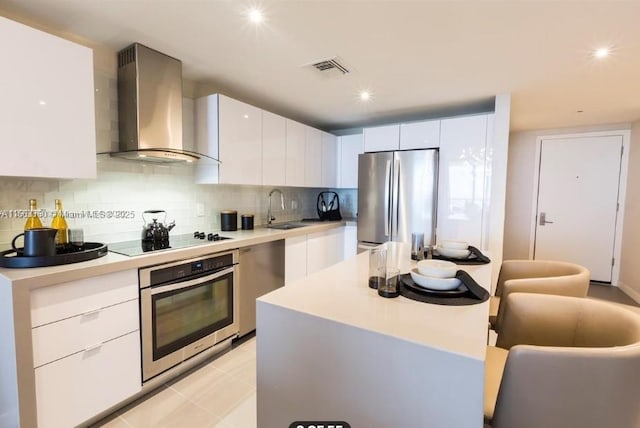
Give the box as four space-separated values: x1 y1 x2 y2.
0 242 109 268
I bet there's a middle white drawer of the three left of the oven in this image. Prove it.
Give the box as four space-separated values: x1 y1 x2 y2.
32 299 139 367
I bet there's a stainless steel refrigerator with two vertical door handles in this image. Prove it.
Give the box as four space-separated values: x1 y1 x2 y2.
358 149 438 247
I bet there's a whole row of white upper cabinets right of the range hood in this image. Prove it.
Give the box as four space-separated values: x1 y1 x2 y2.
195 94 338 187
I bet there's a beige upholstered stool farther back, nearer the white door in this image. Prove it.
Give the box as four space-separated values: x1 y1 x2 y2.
489 260 591 332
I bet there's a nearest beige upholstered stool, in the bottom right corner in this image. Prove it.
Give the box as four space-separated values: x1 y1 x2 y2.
485 293 640 428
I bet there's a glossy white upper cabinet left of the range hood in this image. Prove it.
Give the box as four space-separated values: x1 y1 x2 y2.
0 16 96 178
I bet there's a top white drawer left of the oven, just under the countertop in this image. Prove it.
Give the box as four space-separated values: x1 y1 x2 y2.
31 269 138 327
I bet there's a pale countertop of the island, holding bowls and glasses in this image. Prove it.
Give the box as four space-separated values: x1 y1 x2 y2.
258 244 491 361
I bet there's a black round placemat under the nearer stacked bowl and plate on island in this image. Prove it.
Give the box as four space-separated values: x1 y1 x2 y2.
398 270 489 306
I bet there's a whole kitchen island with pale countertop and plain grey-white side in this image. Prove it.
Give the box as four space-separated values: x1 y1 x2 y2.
257 246 491 428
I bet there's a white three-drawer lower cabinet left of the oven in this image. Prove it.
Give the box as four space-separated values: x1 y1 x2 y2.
31 270 142 428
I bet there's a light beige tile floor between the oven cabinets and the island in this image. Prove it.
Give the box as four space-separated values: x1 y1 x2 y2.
94 336 257 428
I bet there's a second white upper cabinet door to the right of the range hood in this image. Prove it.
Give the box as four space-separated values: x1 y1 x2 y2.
262 110 287 186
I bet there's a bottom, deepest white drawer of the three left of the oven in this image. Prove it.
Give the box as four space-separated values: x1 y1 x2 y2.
35 331 142 428
